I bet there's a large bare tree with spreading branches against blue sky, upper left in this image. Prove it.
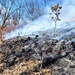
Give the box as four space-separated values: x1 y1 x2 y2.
0 0 21 26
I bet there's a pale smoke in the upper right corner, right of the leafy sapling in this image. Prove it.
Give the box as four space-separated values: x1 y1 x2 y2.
61 0 75 23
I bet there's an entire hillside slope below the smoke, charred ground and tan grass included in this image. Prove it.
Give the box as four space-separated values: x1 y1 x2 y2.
0 27 75 75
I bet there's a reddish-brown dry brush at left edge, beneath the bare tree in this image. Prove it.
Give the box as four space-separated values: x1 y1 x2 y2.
0 21 23 45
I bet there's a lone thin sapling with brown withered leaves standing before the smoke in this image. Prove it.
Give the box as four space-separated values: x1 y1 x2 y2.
50 4 62 32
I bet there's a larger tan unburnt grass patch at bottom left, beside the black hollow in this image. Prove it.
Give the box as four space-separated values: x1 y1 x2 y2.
0 60 40 75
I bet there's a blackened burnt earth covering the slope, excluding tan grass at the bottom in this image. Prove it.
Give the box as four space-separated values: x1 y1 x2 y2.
0 35 75 75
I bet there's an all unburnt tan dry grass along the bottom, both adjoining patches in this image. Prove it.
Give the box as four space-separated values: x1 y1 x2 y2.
0 60 52 75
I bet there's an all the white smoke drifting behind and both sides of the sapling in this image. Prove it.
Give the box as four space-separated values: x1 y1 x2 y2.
5 0 75 39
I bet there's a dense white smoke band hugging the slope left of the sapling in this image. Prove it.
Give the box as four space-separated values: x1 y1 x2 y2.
5 15 53 39
